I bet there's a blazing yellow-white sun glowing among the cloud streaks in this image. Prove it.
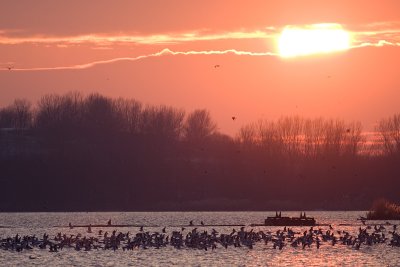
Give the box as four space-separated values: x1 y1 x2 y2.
278 23 350 57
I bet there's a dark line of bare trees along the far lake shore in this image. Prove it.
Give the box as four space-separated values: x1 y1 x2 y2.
0 92 400 213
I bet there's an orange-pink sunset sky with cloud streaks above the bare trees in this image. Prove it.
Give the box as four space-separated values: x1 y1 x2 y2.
0 0 400 135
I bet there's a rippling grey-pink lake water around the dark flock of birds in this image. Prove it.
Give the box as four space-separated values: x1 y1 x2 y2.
0 211 400 266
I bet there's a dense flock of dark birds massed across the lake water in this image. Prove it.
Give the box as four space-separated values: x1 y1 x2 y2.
0 225 400 252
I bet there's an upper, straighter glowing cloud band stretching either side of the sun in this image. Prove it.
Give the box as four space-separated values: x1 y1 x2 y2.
0 22 400 47
